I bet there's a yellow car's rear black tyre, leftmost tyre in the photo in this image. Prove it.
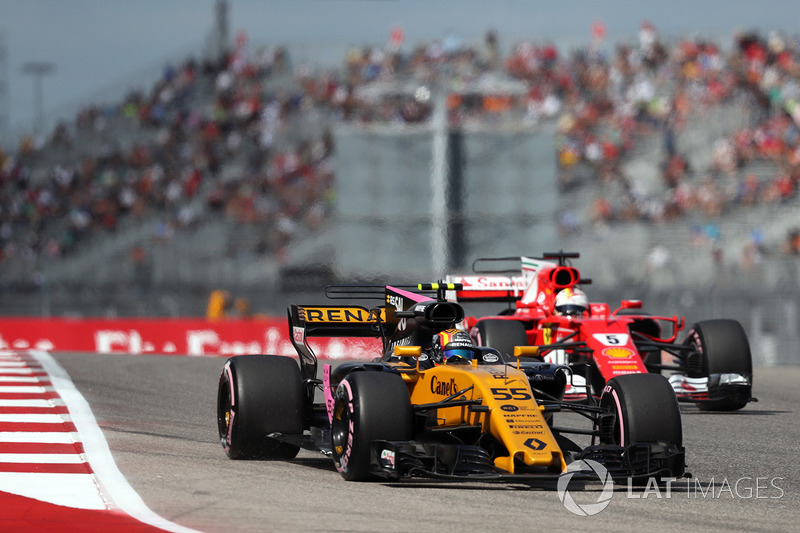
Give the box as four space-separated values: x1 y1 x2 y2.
217 355 304 460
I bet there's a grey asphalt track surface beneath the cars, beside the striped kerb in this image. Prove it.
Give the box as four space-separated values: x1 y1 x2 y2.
55 353 800 533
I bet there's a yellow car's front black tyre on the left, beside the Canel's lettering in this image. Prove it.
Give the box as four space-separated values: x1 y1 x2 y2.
331 371 413 481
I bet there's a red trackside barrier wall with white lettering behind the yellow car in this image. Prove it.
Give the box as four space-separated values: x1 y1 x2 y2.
0 318 381 359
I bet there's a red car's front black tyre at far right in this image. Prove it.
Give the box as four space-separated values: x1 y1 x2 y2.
684 319 753 411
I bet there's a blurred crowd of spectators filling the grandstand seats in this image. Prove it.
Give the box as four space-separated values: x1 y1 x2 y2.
0 20 800 274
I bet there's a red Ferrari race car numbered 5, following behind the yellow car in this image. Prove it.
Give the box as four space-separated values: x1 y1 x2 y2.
448 252 755 411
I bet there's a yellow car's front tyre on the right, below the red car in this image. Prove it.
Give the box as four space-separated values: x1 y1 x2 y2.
600 374 683 447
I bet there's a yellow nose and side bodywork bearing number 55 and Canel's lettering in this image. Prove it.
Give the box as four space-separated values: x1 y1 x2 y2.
395 346 567 474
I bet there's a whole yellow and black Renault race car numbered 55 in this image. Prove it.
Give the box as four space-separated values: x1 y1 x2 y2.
217 283 685 481
